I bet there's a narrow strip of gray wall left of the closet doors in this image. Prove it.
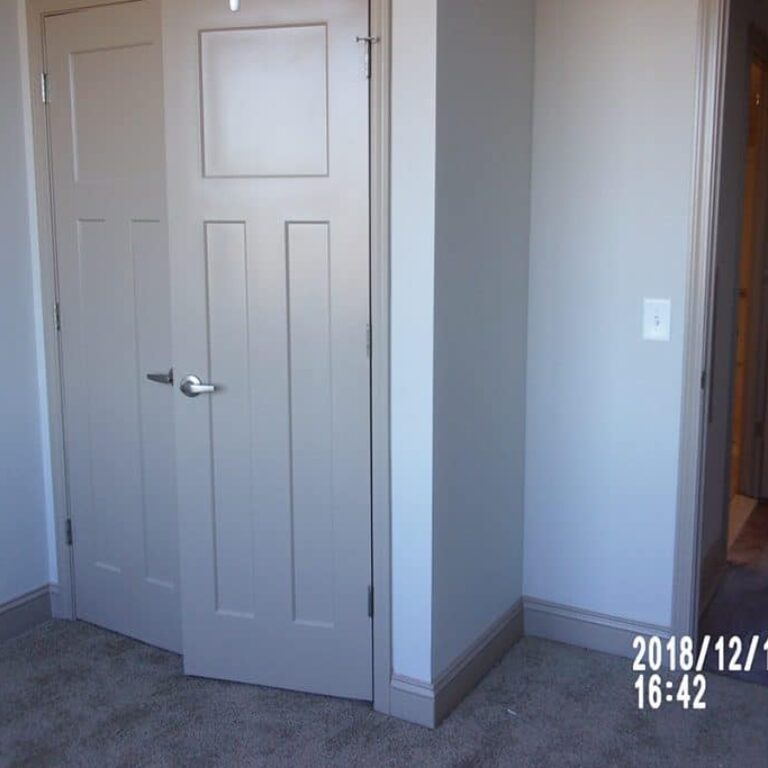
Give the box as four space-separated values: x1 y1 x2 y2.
0 0 49 605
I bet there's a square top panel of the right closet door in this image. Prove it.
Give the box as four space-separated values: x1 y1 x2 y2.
200 24 328 177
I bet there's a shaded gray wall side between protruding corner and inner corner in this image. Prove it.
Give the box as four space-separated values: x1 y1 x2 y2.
432 0 534 677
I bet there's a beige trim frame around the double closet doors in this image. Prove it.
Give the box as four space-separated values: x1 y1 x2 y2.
22 0 392 714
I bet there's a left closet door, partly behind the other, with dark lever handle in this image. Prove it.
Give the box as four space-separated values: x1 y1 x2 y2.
45 0 181 650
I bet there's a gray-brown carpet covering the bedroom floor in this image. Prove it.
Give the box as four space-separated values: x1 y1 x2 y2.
0 623 768 768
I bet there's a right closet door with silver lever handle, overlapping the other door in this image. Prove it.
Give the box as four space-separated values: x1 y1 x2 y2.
163 0 372 699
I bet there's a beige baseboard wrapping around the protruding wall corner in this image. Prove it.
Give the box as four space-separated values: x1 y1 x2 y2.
390 601 523 728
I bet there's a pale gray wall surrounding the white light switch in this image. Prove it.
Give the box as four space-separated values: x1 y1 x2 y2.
524 0 698 625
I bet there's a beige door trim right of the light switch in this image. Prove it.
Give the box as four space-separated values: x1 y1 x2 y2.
672 0 731 639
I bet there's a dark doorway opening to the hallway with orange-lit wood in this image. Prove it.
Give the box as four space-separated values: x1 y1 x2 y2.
699 30 768 685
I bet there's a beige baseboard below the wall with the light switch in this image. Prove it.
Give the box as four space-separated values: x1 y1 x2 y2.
523 597 671 658
